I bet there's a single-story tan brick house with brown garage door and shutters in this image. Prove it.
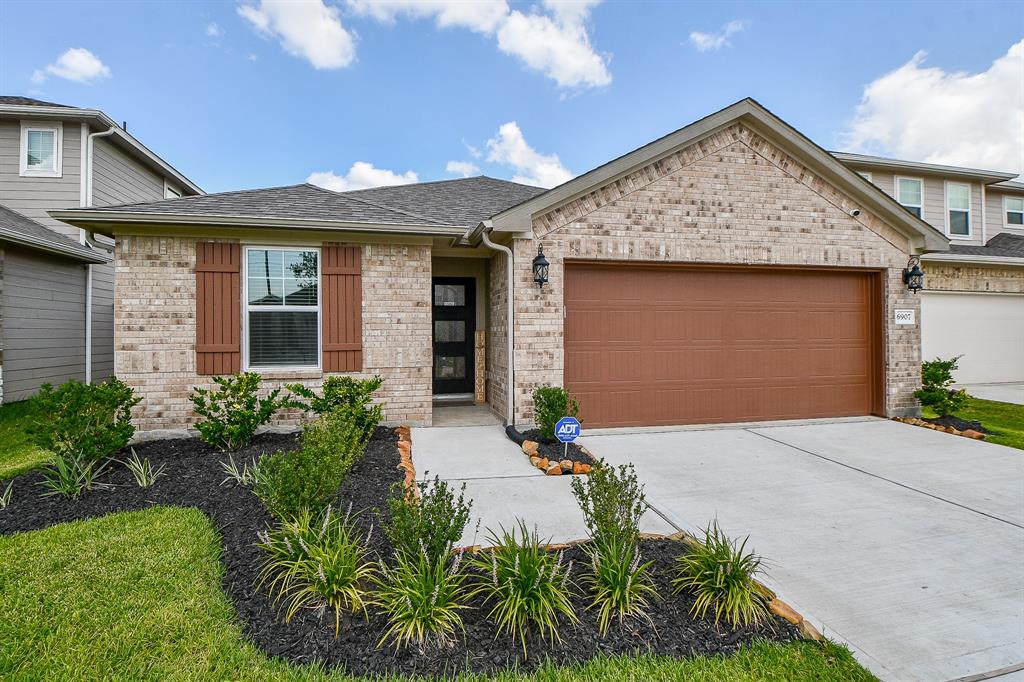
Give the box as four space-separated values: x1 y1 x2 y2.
51 99 978 430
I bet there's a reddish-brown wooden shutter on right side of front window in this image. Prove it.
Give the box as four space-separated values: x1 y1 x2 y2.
321 244 362 372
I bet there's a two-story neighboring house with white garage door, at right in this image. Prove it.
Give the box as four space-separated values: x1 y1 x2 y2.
835 153 1024 383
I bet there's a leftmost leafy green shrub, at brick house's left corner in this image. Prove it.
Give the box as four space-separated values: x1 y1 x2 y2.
30 379 141 464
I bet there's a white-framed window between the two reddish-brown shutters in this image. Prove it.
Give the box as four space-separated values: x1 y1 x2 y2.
242 246 321 371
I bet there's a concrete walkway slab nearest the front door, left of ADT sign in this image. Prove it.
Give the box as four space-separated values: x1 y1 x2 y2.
412 426 544 480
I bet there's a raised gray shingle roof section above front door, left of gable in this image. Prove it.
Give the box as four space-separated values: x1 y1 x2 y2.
342 175 547 227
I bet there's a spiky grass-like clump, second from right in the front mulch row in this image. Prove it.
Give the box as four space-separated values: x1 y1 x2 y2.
583 538 657 635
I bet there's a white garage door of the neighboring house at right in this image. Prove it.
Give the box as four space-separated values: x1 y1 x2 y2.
921 292 1024 384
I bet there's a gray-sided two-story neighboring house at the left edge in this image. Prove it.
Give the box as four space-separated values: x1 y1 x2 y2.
0 96 202 402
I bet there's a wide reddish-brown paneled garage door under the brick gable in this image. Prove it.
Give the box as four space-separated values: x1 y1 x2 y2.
565 264 881 427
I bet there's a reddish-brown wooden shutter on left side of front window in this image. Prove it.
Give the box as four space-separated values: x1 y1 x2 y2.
196 242 242 374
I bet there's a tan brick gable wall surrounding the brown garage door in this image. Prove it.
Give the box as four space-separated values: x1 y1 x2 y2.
514 119 921 422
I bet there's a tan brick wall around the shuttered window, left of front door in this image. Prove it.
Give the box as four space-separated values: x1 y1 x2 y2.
115 236 431 431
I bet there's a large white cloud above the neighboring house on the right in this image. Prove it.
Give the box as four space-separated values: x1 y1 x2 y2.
845 40 1024 178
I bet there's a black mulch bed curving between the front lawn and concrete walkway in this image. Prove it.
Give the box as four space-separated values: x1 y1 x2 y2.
0 428 800 676
